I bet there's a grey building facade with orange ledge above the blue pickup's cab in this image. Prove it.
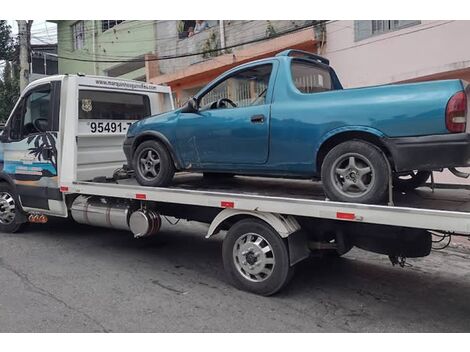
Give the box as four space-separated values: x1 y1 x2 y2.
146 20 323 106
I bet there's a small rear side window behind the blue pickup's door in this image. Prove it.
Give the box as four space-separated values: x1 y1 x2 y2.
291 60 333 93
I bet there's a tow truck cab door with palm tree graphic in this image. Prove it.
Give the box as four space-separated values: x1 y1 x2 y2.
1 81 63 210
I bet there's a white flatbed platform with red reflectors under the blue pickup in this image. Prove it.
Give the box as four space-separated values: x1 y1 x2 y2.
65 173 470 234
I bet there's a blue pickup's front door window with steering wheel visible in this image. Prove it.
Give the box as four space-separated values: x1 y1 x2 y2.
199 64 273 110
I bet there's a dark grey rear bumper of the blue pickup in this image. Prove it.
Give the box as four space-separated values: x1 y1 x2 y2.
384 133 470 172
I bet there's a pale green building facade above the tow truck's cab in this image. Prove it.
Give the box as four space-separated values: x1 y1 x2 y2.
53 20 157 81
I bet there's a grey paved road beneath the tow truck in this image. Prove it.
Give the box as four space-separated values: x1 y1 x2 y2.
0 220 470 332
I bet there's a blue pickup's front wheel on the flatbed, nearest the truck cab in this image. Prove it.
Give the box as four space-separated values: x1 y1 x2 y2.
134 140 175 187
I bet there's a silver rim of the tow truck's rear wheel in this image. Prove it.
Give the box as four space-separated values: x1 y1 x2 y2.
233 232 276 282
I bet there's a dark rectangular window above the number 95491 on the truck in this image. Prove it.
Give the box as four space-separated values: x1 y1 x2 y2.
78 90 151 120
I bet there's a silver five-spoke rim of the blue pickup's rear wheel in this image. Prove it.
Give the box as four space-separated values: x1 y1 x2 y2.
330 153 375 198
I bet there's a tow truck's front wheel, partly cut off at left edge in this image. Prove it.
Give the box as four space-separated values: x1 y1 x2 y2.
0 183 24 233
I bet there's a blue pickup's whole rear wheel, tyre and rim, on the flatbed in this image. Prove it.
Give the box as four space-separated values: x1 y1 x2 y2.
321 140 389 203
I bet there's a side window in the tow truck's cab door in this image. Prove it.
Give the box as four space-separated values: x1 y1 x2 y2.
10 85 51 140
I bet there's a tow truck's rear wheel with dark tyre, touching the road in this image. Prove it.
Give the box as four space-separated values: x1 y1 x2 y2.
222 219 293 296
